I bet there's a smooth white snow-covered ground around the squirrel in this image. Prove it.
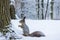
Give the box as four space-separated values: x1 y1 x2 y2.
11 19 60 40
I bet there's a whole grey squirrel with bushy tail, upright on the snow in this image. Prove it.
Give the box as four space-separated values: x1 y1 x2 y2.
19 17 45 37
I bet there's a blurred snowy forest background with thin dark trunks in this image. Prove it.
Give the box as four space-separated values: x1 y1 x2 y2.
13 0 60 20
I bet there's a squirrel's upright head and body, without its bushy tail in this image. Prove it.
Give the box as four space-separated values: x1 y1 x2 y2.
19 17 29 36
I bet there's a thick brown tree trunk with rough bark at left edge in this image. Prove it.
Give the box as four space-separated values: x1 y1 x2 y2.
0 0 10 32
